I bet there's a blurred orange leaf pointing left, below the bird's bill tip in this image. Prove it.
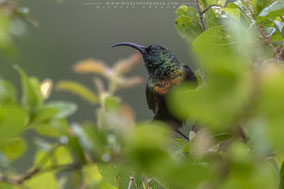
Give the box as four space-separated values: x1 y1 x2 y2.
73 59 111 78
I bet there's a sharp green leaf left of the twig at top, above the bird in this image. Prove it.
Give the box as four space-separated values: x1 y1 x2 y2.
176 5 202 42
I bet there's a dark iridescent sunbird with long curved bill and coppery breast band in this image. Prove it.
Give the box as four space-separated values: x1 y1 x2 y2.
111 42 197 140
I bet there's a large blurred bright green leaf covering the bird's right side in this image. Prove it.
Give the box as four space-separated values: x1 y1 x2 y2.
170 26 250 127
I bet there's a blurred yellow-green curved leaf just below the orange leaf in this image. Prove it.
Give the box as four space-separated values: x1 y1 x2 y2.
56 81 98 104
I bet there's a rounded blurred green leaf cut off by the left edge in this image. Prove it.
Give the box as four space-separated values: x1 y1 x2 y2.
0 106 27 144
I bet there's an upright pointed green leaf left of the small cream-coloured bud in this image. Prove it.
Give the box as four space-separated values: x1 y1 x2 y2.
15 66 42 111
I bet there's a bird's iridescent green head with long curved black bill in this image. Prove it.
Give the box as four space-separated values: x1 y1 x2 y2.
111 42 179 75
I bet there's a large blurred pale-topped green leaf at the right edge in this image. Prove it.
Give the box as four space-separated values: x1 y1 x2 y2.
255 64 284 150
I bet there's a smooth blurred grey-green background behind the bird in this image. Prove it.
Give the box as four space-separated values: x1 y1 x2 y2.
0 0 195 121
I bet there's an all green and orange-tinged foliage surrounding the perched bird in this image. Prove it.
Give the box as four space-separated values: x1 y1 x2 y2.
0 0 284 189
